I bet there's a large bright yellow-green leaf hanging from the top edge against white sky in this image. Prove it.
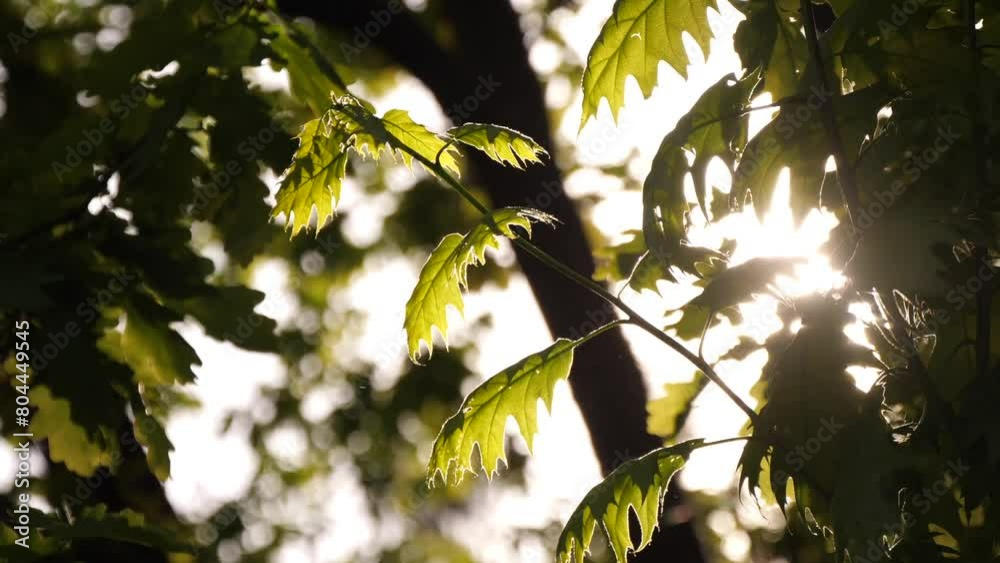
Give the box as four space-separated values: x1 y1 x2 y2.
580 0 718 128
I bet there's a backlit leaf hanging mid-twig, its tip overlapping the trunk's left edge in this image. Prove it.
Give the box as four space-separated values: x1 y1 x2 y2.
403 207 555 361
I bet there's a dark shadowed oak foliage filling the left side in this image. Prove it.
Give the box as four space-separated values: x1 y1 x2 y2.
0 0 476 561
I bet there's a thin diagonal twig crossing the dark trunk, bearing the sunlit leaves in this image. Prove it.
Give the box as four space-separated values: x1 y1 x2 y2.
398 148 757 423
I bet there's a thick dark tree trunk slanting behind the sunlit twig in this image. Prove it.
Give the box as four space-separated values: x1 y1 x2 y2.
278 0 704 563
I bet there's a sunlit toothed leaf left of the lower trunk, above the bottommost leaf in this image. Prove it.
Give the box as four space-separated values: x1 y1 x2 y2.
427 338 580 485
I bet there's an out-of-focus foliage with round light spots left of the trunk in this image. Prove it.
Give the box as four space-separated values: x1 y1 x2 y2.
0 0 528 563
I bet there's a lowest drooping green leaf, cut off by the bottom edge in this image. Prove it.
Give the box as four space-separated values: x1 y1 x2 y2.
556 440 703 563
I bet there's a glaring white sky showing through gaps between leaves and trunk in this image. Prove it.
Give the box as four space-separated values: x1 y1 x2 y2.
0 0 876 563
